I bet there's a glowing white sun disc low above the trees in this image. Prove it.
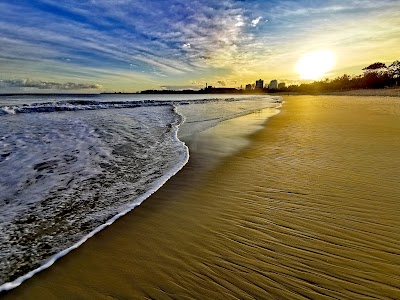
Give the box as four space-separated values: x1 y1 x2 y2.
296 50 336 80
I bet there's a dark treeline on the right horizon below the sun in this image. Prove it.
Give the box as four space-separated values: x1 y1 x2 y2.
276 60 400 93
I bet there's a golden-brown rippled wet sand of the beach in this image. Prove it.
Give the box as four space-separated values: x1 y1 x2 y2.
4 96 400 299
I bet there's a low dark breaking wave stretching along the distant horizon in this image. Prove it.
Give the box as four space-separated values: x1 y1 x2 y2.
0 97 281 115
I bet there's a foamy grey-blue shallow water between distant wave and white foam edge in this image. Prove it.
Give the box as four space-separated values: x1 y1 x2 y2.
0 107 187 283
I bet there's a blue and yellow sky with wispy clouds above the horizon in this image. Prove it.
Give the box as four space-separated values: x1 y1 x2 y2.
0 0 400 93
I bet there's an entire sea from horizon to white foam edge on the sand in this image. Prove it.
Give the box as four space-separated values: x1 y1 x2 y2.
0 95 280 291
